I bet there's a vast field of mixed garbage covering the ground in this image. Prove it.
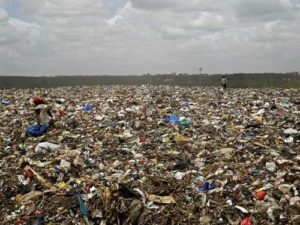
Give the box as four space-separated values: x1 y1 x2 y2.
0 85 300 225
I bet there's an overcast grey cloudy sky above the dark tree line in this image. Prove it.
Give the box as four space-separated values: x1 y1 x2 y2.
0 0 300 75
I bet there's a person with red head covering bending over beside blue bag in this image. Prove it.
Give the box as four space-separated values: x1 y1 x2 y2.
32 97 54 126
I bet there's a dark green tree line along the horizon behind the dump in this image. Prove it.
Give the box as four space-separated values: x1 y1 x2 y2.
0 72 300 89
